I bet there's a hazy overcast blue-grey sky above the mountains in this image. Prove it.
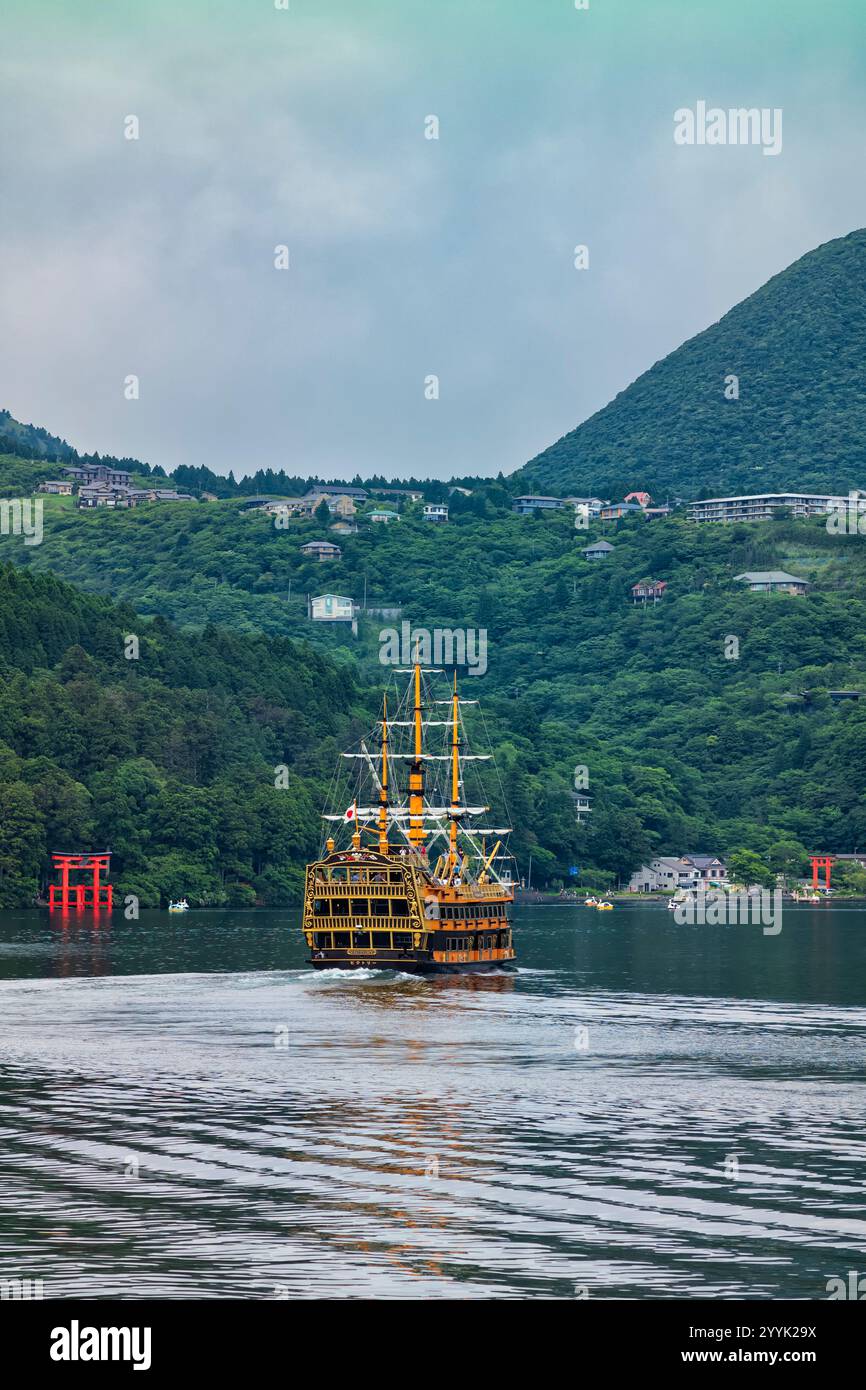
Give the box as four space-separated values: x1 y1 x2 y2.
0 0 866 477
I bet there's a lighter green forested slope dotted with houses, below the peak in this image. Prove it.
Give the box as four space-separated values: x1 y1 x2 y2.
0 485 866 881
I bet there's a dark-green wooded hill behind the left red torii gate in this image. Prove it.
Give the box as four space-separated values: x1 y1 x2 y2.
0 566 370 906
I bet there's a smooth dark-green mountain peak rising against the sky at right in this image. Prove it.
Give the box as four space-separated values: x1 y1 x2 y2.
510 229 866 499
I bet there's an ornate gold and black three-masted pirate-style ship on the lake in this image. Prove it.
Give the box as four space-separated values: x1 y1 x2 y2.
303 664 514 974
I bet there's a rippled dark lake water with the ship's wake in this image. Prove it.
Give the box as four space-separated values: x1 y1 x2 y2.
0 904 866 1298
